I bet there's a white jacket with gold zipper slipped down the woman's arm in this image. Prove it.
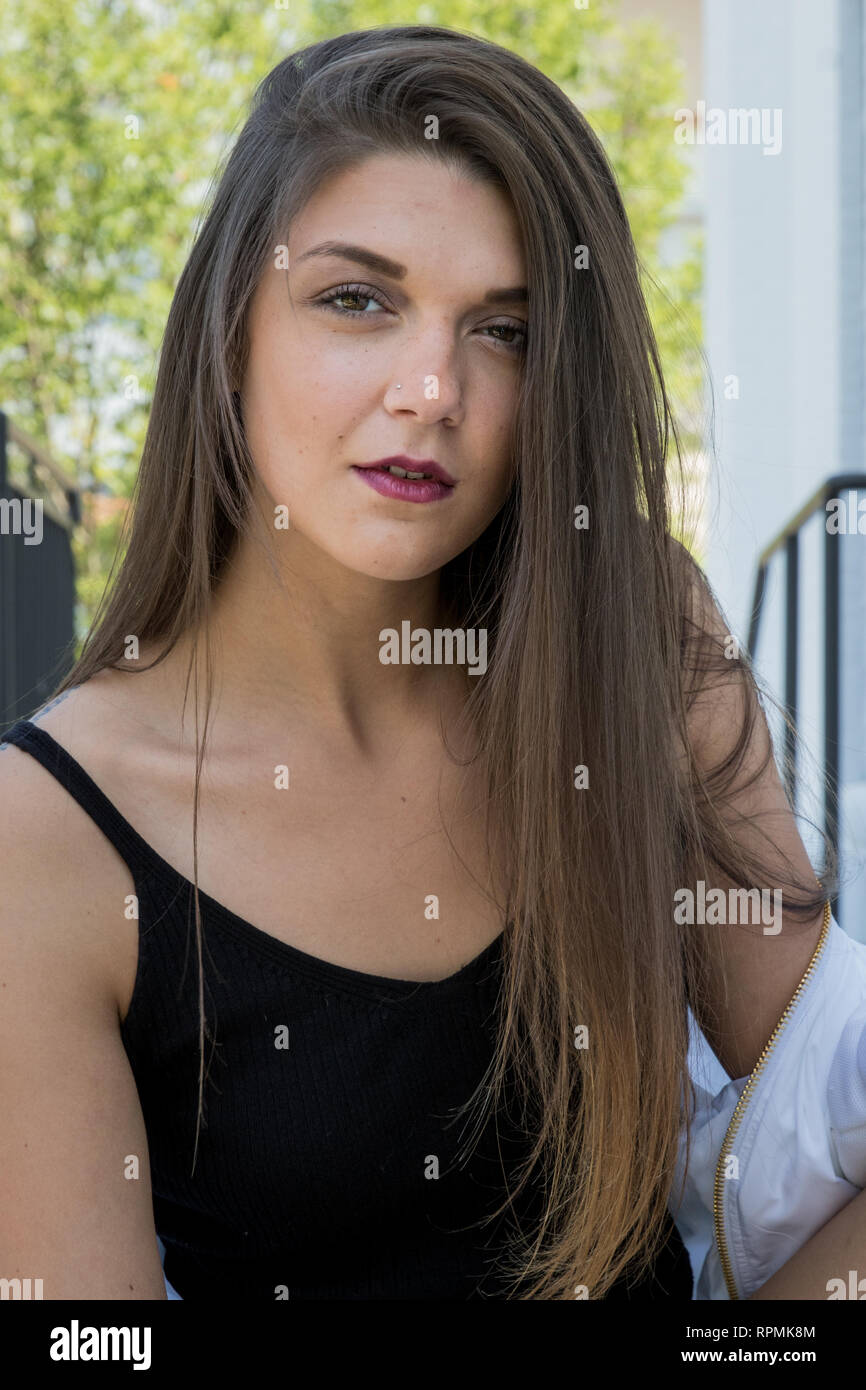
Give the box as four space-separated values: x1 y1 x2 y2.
669 906 866 1300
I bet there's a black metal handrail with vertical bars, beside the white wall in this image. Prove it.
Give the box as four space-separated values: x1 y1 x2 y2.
749 473 866 917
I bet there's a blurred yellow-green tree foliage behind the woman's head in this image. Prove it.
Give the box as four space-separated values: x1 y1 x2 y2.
0 0 701 634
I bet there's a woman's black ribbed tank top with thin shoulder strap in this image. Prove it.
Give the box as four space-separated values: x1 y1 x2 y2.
1 720 692 1301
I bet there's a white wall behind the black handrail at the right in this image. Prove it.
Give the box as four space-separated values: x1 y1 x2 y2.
701 0 866 940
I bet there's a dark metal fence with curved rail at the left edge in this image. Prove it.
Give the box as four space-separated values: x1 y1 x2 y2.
0 410 81 728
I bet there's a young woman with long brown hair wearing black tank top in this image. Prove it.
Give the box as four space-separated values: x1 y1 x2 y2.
0 26 866 1300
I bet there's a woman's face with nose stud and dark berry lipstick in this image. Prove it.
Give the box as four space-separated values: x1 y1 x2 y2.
242 154 527 580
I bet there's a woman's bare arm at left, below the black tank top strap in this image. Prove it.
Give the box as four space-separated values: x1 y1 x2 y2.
0 746 165 1300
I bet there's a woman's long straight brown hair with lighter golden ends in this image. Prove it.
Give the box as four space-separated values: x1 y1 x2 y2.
47 26 824 1298
